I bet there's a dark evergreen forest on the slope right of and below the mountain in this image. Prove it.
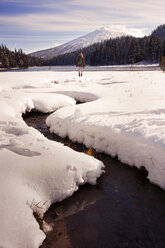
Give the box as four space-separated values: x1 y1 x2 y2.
46 35 165 65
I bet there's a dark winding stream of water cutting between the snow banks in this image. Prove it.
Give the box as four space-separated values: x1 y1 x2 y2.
24 113 165 248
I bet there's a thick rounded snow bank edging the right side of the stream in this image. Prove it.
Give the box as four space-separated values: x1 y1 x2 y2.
46 104 165 188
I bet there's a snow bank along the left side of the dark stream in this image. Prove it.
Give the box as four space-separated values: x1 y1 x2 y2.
0 73 103 248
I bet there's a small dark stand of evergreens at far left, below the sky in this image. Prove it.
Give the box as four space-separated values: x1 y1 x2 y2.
0 44 45 69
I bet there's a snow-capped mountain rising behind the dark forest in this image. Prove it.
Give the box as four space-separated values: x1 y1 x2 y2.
30 27 125 59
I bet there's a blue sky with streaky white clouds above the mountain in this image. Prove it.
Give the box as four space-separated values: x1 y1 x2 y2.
0 0 165 53
